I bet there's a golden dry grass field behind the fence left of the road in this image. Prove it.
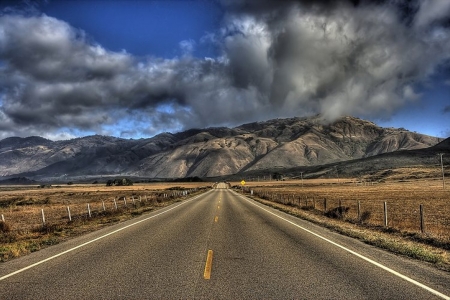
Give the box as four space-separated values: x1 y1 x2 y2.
0 183 211 230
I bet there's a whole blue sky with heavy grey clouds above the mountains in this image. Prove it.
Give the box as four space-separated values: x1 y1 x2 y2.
0 0 450 140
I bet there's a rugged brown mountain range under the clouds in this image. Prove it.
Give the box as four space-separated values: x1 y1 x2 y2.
0 117 442 178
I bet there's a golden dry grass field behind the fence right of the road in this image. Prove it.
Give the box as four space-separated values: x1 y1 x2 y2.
237 179 450 241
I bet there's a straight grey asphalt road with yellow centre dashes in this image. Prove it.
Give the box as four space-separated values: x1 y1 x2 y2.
0 189 450 299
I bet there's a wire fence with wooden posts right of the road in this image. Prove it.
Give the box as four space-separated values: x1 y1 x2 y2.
242 188 450 239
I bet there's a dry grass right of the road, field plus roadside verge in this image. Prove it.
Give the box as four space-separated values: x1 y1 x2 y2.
231 178 450 271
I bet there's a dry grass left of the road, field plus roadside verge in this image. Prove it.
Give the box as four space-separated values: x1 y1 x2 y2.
0 183 211 261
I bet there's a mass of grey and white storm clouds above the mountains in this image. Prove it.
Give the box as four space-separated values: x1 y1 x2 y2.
0 0 450 138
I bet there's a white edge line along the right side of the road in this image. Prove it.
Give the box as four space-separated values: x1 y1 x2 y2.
233 191 450 300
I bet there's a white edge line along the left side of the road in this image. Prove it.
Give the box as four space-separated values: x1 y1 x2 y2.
0 193 211 281
